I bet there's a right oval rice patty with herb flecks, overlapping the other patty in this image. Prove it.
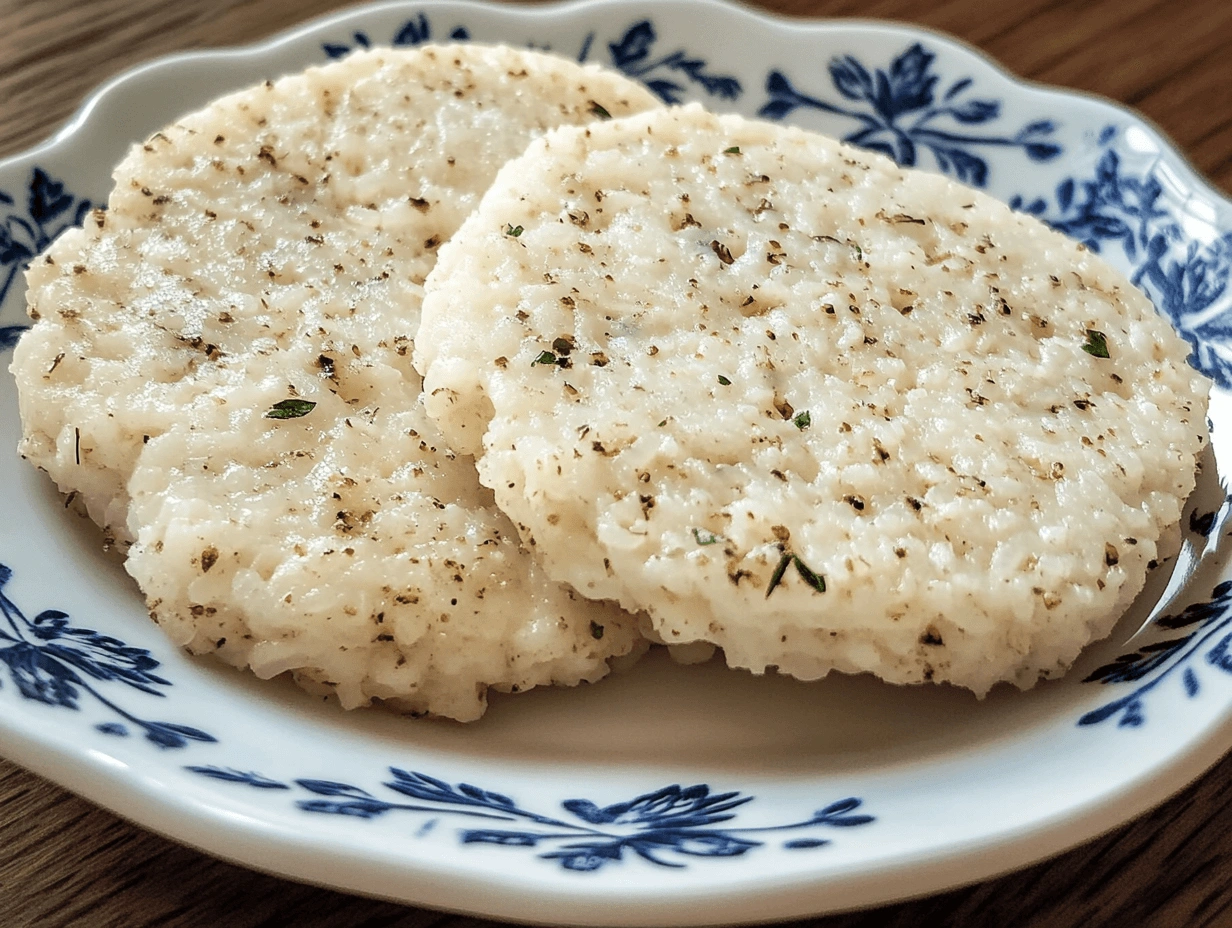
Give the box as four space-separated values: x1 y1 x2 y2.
415 107 1206 693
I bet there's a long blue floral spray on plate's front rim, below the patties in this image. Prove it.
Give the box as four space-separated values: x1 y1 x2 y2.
186 767 876 873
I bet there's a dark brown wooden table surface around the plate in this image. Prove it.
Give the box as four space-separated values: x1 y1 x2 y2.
0 0 1232 928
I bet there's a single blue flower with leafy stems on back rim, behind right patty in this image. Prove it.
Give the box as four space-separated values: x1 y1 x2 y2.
758 42 1062 187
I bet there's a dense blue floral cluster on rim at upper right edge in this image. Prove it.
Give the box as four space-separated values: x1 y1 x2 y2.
1010 126 1232 388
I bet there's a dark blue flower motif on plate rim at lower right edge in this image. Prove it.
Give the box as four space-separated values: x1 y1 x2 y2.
1078 580 1232 728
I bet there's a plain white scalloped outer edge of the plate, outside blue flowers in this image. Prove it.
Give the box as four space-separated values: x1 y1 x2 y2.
0 0 1232 924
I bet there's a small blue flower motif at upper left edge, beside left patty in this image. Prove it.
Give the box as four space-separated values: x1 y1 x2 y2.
0 168 94 308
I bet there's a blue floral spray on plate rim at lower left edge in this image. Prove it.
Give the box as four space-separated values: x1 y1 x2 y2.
0 564 217 748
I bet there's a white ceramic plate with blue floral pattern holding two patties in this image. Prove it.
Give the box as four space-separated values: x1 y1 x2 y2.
0 0 1232 926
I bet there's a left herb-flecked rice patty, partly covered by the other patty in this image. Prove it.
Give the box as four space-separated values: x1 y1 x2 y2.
14 46 655 718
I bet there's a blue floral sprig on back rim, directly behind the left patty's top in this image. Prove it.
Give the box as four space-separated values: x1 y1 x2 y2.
322 14 743 104
